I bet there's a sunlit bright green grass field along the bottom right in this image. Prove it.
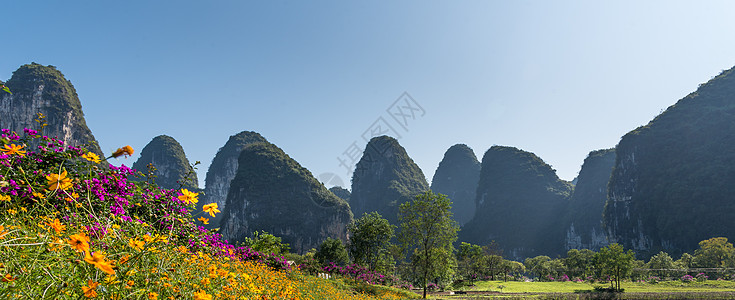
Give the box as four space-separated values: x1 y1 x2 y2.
422 280 735 299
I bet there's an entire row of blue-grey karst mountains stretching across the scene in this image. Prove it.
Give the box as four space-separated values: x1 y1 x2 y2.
0 64 735 259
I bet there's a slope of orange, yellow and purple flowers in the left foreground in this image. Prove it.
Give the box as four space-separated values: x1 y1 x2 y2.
0 123 410 299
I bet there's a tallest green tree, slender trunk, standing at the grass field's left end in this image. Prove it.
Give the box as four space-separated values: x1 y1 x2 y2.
398 191 459 298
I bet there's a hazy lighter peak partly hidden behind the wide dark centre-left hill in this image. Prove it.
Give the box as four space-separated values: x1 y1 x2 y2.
197 131 268 228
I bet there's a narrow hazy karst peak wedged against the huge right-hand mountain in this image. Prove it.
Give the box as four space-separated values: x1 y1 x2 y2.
565 149 615 251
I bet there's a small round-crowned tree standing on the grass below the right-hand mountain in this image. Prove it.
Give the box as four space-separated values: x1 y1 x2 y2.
595 243 635 291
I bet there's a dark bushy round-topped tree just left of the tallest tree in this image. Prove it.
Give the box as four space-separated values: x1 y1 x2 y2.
347 212 394 271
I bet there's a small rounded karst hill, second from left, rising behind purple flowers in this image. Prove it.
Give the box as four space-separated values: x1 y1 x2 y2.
133 135 199 190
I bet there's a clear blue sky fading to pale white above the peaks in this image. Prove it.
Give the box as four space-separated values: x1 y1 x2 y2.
0 0 735 186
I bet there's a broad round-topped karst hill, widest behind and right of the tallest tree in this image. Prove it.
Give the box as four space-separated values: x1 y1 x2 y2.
460 146 572 259
